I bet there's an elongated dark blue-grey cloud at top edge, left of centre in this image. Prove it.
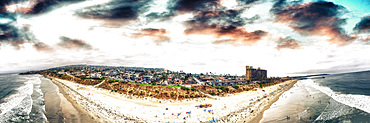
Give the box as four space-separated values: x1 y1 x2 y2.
76 0 151 20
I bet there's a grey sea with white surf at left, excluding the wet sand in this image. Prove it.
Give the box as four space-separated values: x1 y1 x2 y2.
0 74 46 122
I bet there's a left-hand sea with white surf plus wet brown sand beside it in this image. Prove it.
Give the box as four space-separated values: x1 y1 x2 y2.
0 74 64 123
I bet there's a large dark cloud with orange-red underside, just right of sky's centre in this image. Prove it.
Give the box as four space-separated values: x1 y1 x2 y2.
184 10 267 44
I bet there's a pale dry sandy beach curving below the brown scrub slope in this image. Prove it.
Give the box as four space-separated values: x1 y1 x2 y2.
45 77 297 122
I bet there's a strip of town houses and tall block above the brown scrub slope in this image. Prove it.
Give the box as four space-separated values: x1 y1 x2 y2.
26 65 292 87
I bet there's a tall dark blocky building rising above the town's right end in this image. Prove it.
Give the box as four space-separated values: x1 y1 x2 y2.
245 66 267 81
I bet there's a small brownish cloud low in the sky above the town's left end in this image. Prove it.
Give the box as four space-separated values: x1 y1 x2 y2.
58 36 92 50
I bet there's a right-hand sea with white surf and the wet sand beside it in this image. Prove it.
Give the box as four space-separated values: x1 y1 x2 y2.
261 71 370 123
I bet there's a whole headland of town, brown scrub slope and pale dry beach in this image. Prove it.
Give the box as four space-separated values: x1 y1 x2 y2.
21 65 302 122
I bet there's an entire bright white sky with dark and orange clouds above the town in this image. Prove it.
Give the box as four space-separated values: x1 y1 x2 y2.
0 0 370 77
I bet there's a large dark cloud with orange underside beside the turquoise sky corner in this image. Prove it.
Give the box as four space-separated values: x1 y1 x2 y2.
270 1 353 44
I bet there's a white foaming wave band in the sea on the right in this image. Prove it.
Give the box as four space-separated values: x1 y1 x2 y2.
301 79 370 113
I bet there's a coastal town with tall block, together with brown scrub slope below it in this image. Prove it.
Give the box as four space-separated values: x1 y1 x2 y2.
23 65 294 99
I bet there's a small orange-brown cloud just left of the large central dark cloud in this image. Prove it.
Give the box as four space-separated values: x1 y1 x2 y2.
132 28 170 44
